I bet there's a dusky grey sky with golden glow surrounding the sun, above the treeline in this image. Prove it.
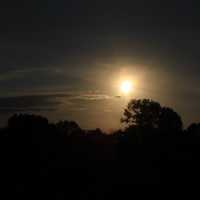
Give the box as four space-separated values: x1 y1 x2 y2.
0 0 200 131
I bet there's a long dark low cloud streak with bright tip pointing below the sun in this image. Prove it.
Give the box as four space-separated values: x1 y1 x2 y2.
0 93 111 114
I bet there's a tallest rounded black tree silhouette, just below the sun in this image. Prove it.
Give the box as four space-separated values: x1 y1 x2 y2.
121 99 182 131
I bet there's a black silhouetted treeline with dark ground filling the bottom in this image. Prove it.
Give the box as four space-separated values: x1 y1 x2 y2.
0 99 200 199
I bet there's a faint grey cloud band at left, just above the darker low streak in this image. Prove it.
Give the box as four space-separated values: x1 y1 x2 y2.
0 66 96 96
